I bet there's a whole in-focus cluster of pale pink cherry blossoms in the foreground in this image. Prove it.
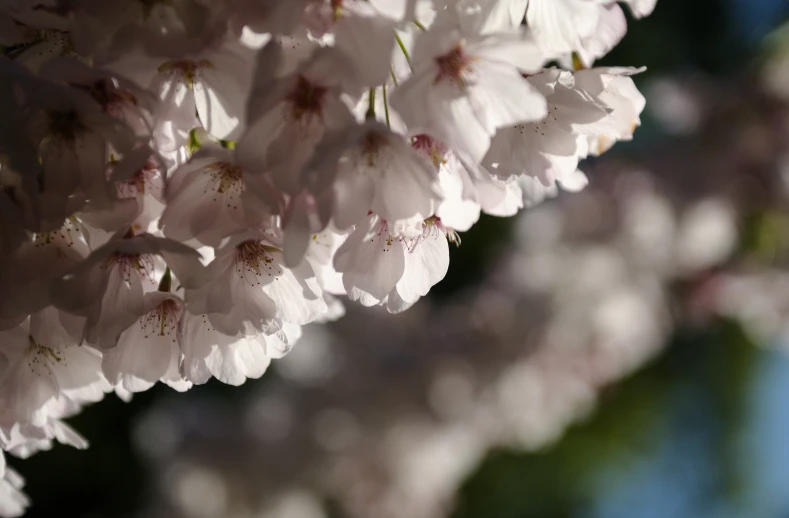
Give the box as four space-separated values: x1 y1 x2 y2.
0 0 655 516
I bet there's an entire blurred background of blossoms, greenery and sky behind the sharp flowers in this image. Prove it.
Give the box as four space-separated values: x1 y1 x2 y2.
11 0 789 518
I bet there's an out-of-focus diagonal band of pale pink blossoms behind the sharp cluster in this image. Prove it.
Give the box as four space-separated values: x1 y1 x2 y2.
118 45 789 518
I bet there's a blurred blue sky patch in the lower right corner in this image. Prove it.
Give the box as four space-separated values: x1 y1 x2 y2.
581 349 789 518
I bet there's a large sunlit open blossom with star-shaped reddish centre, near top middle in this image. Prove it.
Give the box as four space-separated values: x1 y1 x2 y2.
392 11 546 161
